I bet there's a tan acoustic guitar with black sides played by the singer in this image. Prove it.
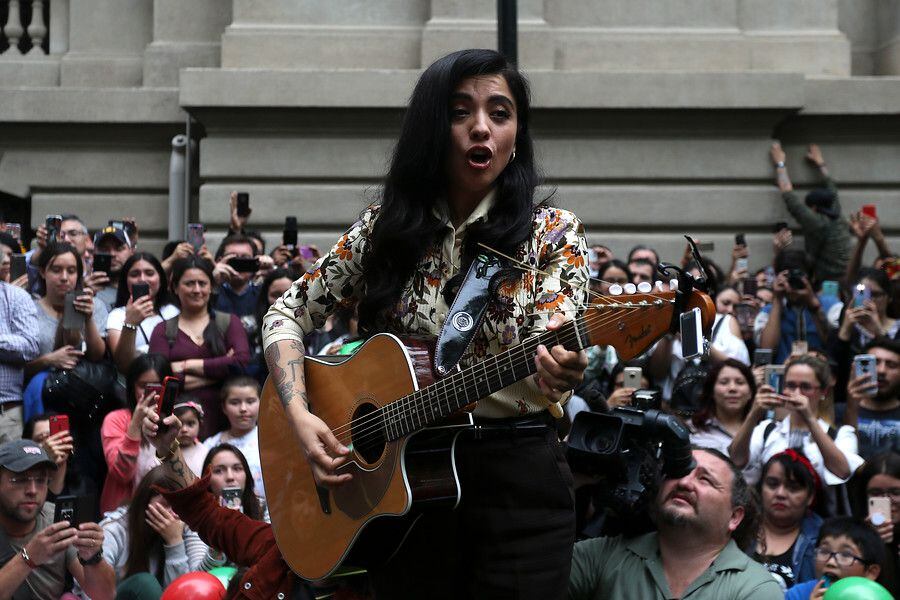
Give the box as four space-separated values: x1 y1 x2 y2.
259 291 715 580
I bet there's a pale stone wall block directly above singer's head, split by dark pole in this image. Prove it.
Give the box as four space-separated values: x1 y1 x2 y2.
422 0 553 70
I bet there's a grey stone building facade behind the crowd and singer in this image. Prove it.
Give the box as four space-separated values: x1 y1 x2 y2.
0 0 900 264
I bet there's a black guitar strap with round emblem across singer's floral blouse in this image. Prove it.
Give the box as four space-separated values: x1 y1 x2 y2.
434 254 502 376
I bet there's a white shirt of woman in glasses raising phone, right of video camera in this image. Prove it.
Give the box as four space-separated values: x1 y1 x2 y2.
744 415 863 485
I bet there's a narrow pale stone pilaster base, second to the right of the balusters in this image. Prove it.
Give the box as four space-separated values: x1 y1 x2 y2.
144 0 231 87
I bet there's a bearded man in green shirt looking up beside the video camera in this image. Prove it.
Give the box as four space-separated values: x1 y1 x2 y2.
569 449 784 600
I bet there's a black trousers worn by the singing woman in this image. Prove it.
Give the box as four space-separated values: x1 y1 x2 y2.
370 427 575 600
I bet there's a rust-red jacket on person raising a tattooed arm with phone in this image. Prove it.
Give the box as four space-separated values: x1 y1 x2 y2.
157 475 313 600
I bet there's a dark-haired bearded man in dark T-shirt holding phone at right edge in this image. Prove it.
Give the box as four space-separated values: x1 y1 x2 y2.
844 338 900 460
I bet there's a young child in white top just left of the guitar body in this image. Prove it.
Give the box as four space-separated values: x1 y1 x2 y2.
203 375 266 499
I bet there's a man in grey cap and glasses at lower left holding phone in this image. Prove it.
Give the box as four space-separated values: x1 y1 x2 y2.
0 440 116 600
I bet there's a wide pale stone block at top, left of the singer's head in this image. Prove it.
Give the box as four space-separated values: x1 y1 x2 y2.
222 0 428 70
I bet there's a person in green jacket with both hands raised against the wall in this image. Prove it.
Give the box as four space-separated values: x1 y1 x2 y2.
769 142 850 283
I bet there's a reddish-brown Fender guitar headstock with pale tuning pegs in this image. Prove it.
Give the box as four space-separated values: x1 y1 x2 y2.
583 290 716 360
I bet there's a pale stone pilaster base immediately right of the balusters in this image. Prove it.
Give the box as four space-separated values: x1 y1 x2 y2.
59 0 153 87
